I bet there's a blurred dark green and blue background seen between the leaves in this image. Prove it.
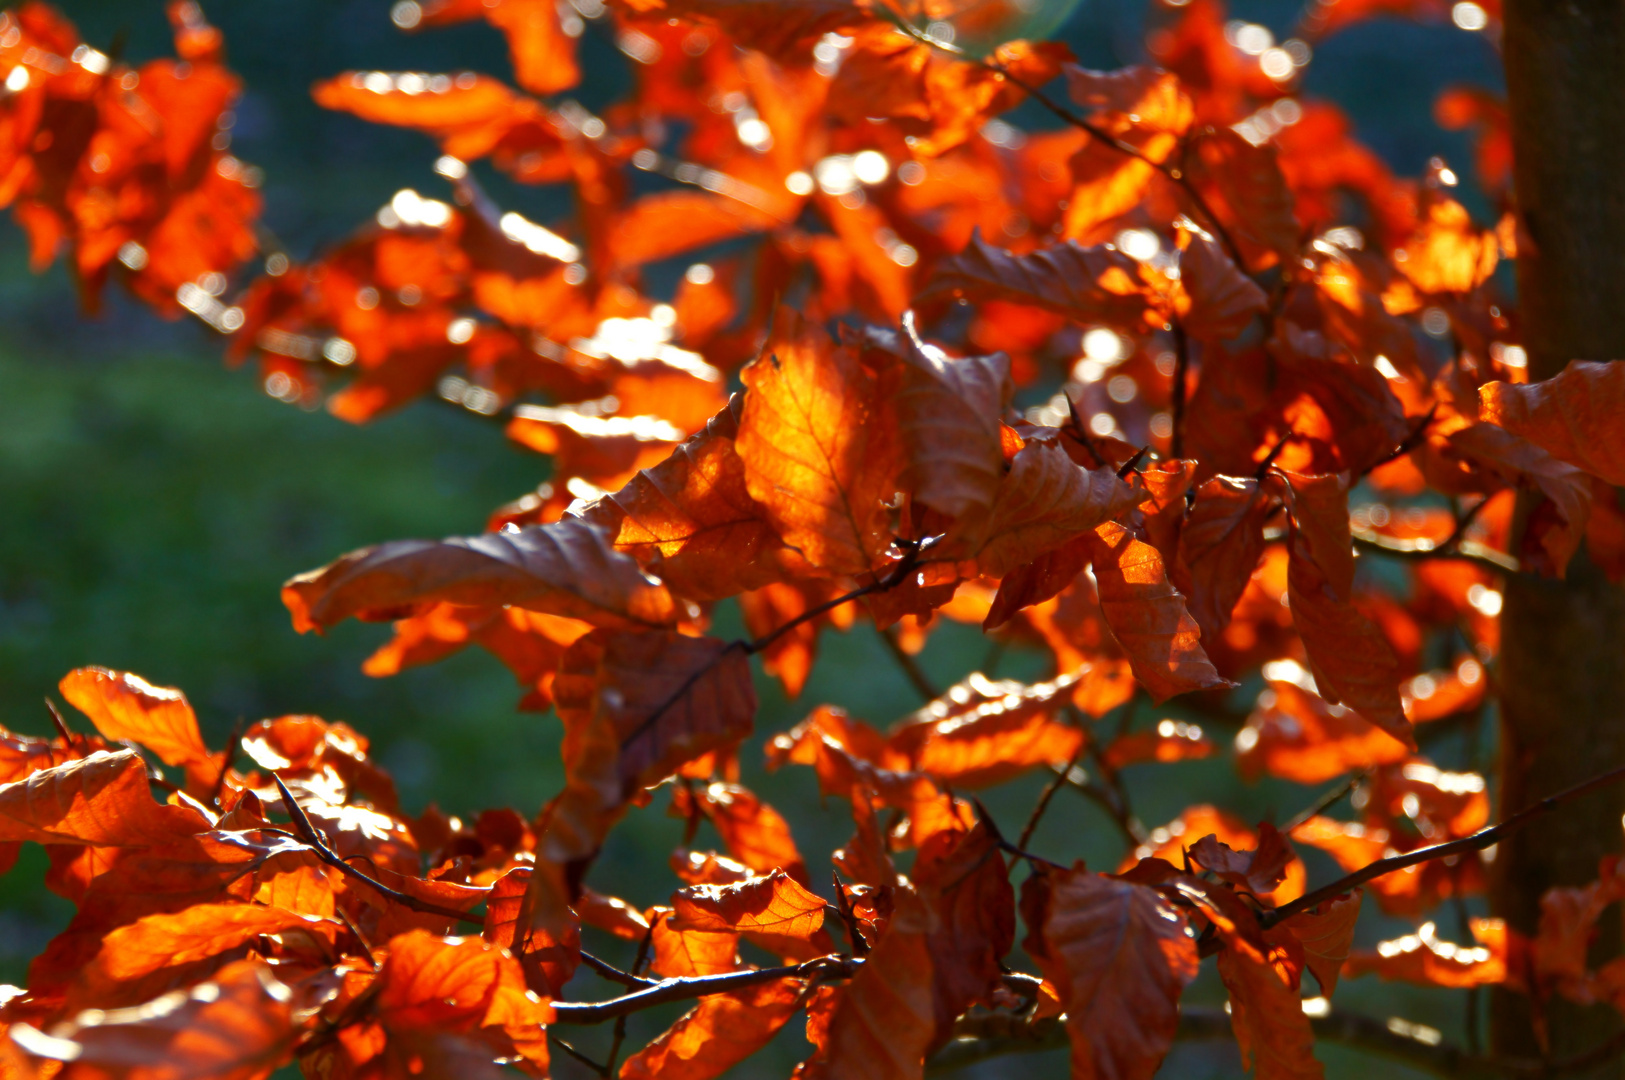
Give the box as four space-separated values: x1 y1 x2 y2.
0 0 1500 1077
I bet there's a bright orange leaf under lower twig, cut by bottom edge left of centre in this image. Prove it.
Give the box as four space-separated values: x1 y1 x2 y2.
621 979 804 1080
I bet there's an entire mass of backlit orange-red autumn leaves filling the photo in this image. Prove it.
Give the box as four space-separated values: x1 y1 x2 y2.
9 0 1625 1080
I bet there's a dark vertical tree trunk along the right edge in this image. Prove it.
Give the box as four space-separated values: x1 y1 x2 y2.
1492 0 1625 1058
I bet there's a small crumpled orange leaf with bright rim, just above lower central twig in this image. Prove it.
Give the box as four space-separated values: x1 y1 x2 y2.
668 870 834 960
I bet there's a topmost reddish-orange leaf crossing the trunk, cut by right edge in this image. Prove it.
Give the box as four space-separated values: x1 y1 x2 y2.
1479 361 1625 487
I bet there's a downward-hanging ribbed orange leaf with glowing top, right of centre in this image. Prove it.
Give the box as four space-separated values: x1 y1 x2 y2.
1089 523 1232 702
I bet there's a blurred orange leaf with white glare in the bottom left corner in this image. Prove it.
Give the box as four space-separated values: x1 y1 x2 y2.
11 960 297 1080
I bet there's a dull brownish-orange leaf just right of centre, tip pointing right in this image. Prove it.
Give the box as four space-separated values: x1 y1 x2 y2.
977 440 1144 577
